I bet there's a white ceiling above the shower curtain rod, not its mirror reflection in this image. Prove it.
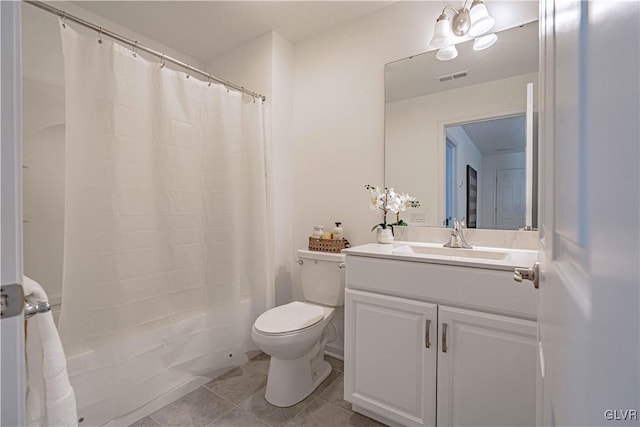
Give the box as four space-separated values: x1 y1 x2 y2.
72 1 394 63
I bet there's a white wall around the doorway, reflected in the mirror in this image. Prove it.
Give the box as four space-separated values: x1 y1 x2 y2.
385 73 538 226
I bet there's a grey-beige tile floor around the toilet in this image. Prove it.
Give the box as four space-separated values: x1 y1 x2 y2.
130 353 384 427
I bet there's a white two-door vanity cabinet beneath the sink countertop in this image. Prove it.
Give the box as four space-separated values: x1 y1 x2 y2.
345 253 537 426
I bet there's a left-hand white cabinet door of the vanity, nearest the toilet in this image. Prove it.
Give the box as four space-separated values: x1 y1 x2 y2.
344 289 437 426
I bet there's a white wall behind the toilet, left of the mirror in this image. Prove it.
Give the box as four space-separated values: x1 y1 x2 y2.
292 2 537 358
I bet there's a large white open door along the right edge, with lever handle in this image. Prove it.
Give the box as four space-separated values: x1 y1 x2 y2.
538 0 640 426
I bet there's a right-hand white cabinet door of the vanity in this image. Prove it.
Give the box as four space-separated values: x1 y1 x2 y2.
438 306 537 427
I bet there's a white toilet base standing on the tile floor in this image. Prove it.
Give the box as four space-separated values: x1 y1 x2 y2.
264 354 331 408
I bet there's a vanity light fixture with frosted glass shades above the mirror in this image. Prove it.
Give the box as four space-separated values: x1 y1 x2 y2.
429 0 497 61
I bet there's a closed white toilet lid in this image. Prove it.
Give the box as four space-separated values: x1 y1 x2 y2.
254 301 324 334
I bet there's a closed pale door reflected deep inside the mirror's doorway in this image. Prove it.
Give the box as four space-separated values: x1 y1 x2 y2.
496 169 525 230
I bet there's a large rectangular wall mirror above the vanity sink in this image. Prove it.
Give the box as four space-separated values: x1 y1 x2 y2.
384 21 538 229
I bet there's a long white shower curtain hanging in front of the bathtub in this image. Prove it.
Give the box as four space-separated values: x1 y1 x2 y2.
59 25 273 425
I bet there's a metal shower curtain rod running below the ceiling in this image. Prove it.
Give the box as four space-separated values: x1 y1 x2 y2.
24 0 267 101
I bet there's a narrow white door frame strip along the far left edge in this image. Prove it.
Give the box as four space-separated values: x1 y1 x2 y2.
0 1 25 426
